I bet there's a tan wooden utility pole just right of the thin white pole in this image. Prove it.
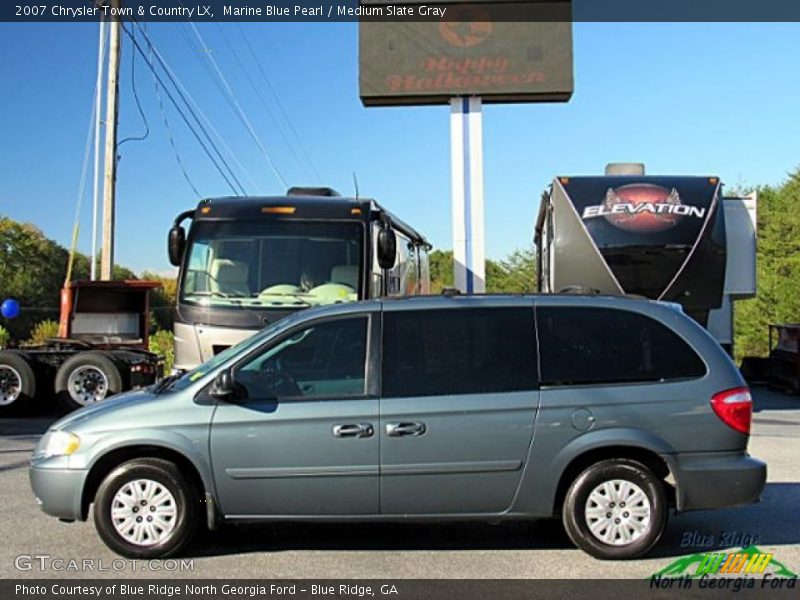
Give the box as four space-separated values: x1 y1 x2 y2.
100 0 122 281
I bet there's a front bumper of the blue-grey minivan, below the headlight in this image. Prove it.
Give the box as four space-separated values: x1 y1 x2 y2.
28 465 88 520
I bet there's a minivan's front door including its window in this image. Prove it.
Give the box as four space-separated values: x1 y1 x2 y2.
210 313 378 516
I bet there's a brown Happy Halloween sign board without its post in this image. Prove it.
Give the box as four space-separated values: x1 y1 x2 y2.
359 0 573 106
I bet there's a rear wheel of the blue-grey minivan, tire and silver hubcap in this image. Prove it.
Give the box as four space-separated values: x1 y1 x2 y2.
562 459 667 560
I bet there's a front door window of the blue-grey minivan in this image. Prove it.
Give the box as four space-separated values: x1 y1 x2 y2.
234 316 368 399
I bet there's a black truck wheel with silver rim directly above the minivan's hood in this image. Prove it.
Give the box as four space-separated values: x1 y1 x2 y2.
55 352 123 410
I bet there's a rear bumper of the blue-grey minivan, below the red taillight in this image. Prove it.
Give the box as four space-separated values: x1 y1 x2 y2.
670 452 767 511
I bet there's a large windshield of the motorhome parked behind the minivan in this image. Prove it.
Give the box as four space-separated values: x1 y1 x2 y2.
180 220 364 308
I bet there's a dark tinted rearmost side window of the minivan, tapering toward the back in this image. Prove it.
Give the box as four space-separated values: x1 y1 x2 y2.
536 307 706 385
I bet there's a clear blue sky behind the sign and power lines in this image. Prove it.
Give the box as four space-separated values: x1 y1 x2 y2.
0 23 800 272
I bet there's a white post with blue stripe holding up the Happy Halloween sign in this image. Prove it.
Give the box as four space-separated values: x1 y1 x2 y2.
450 97 486 294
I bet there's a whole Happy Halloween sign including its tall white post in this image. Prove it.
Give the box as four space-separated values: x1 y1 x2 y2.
359 0 573 294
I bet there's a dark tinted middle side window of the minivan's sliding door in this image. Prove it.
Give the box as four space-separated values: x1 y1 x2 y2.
382 308 537 398
